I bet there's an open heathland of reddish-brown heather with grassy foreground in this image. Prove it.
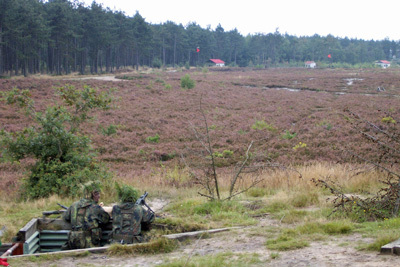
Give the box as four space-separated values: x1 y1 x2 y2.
0 68 400 266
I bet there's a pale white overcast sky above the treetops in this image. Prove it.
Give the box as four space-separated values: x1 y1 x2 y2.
81 0 400 41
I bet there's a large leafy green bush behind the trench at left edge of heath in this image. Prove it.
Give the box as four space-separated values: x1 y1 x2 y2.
0 85 112 198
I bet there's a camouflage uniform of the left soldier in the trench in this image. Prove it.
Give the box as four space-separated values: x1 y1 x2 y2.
64 198 110 249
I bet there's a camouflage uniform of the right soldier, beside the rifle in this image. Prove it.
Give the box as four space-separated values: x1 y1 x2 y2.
111 202 154 244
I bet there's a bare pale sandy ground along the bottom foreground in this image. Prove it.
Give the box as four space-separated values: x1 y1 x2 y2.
14 199 400 267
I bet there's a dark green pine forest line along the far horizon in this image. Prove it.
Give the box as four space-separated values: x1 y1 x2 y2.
0 0 400 76
